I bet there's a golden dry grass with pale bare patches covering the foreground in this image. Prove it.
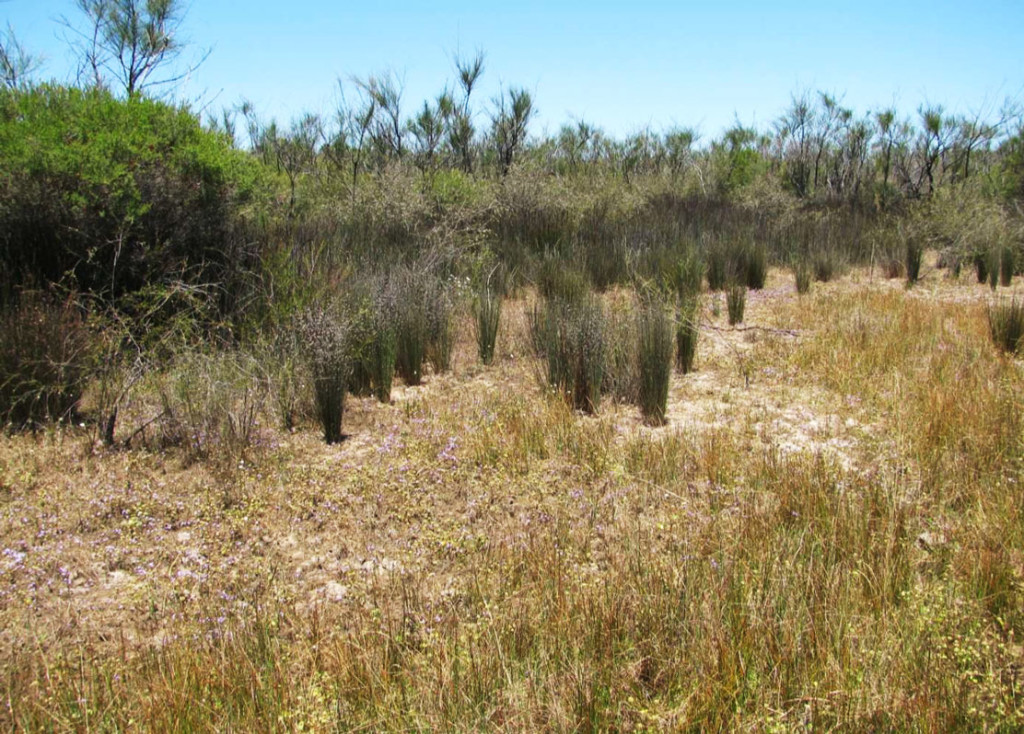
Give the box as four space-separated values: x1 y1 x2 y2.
0 251 1024 731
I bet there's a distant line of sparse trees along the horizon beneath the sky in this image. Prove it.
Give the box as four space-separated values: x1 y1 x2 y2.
224 64 1024 210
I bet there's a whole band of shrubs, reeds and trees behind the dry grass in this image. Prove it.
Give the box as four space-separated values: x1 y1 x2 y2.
0 10 1024 436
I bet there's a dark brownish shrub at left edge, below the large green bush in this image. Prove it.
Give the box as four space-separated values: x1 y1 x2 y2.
0 292 90 429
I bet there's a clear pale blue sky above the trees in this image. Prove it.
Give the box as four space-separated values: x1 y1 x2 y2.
0 0 1024 139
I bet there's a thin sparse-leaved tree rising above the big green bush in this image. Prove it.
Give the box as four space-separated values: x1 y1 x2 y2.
65 0 205 97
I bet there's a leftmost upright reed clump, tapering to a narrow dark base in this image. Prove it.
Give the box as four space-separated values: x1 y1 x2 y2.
301 307 351 443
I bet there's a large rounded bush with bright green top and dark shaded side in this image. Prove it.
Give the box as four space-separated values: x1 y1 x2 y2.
0 86 260 294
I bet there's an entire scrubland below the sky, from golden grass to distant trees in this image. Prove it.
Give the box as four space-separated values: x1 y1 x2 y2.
0 4 1024 731
